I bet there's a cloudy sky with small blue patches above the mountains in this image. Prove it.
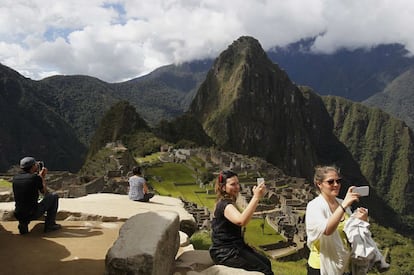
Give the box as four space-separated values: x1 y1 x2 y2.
0 0 414 82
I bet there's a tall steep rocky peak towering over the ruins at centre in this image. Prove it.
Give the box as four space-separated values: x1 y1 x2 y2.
189 36 315 175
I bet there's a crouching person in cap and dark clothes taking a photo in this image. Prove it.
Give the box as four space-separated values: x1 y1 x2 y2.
13 157 61 234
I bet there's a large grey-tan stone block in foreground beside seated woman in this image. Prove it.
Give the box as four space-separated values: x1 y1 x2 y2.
105 211 180 275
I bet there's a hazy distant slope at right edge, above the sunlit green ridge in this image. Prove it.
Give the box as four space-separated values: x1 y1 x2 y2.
363 68 414 129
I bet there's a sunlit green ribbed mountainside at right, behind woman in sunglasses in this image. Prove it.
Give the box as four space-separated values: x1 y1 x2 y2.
324 96 414 223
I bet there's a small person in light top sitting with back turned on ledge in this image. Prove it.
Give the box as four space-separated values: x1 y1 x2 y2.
128 166 154 202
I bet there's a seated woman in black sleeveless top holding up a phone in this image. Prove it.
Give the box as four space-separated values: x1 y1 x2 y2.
210 171 273 275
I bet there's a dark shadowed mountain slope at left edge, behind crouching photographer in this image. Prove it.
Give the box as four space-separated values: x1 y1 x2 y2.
0 64 86 171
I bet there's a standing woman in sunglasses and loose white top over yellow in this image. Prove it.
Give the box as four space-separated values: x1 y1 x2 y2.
305 166 360 275
